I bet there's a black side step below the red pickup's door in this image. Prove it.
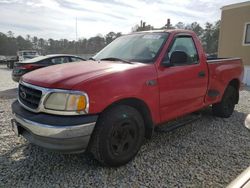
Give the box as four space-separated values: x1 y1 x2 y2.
155 113 201 132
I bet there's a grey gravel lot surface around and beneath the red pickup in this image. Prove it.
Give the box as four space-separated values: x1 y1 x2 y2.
0 64 250 187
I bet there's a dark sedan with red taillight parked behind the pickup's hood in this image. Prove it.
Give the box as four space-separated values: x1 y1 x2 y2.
12 54 85 82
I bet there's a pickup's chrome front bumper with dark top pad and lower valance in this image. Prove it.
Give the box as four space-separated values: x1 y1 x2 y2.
12 101 98 153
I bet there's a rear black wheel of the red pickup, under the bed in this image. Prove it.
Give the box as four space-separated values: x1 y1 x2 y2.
212 85 238 118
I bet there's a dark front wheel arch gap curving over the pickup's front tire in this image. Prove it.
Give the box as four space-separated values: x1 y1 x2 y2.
101 98 154 139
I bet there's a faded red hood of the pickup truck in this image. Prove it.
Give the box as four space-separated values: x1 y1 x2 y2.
22 61 145 89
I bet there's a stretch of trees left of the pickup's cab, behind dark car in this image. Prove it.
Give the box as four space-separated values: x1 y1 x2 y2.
0 31 122 56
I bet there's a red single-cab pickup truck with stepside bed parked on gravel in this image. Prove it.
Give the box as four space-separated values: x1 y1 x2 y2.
12 30 243 166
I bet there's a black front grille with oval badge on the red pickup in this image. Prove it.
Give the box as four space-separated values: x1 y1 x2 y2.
18 84 42 109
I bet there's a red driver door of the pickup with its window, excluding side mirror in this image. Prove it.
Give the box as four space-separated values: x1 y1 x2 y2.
158 35 208 122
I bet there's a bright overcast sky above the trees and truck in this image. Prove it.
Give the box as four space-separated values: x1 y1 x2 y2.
0 0 244 40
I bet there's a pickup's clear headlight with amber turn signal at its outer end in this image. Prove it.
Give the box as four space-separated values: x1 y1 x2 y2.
44 92 88 114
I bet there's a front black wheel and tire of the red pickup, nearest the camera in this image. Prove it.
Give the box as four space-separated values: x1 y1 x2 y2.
89 105 145 167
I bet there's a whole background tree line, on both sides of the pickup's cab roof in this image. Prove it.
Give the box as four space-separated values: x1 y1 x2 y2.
0 19 220 56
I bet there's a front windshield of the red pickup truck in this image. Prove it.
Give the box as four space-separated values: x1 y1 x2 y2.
93 33 168 63
